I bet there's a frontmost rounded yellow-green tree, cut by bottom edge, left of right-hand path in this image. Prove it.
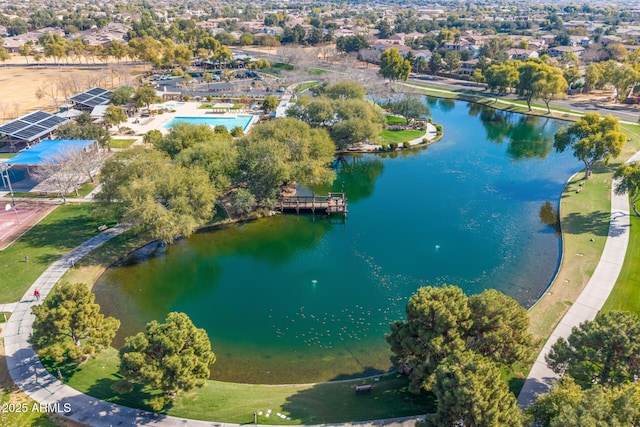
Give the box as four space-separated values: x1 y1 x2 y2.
416 352 522 427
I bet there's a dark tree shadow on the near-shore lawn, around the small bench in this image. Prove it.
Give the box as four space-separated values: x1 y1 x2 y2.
282 373 436 424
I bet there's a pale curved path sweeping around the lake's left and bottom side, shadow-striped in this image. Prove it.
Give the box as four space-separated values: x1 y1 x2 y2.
4 227 422 427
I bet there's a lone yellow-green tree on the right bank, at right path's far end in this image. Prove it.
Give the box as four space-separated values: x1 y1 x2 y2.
553 113 627 179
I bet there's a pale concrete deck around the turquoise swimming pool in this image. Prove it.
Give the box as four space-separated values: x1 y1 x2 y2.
125 101 258 137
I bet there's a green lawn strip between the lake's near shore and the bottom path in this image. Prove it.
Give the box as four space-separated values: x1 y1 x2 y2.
47 349 435 424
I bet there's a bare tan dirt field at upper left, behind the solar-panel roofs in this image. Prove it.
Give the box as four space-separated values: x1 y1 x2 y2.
0 57 143 118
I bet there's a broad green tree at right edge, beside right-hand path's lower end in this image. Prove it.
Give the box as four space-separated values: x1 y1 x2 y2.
546 311 640 388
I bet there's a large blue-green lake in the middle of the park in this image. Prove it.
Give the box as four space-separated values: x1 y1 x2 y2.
94 99 580 384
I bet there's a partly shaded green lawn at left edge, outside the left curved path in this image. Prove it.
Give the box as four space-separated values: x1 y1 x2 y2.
0 203 115 303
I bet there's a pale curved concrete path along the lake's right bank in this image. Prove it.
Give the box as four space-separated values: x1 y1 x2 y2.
518 181 630 408
